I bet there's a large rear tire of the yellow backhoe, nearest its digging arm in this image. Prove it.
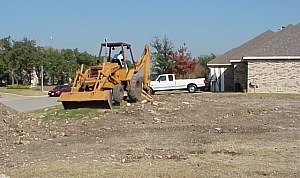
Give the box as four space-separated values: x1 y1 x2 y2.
128 75 142 102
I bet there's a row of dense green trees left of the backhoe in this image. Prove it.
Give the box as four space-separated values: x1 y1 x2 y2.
0 37 97 85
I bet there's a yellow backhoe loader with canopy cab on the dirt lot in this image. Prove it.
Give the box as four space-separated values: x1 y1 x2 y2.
58 42 153 109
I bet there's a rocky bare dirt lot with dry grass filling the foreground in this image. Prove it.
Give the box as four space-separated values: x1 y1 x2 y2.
0 92 300 177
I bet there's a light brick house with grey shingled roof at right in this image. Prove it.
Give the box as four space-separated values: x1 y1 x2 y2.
207 24 300 93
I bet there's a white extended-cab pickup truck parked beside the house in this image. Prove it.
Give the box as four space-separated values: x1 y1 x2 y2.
150 74 205 94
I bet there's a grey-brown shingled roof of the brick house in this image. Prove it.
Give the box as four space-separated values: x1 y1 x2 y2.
208 24 300 65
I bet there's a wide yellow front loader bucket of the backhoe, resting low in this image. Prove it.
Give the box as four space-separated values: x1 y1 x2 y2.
58 90 112 109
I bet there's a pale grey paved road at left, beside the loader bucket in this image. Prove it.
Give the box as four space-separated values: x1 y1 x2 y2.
0 92 61 112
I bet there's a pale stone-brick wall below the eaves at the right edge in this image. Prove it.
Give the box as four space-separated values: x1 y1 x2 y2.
248 60 300 93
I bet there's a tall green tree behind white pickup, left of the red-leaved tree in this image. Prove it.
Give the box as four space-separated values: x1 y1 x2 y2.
150 36 176 75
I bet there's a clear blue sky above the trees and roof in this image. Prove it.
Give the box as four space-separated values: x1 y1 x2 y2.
0 0 300 57
